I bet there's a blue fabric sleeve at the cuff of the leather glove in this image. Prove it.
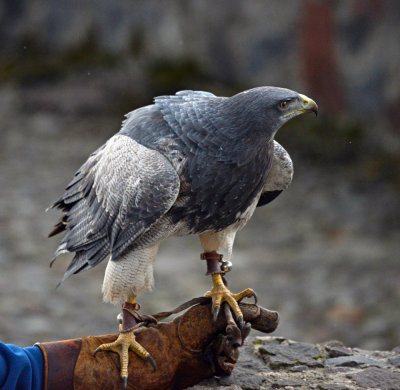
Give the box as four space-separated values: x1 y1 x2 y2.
0 342 44 390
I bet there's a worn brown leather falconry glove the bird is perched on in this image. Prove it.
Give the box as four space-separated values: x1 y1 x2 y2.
37 298 279 390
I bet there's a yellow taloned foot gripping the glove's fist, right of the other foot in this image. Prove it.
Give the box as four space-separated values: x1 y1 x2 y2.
204 274 257 328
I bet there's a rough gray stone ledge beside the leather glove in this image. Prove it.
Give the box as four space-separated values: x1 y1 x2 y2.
191 336 400 390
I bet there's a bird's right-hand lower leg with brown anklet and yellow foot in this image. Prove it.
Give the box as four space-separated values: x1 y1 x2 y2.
201 252 256 328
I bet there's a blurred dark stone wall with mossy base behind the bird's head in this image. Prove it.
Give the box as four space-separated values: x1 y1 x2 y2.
0 0 400 185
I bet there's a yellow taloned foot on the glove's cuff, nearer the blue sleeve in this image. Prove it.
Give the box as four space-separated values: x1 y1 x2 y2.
94 330 157 389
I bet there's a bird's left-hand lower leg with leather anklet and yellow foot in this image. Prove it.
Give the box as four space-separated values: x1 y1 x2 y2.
94 297 157 389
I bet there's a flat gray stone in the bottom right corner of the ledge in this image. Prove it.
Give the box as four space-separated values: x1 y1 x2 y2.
347 367 400 390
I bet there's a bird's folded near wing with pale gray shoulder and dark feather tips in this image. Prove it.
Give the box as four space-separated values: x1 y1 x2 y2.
51 134 180 279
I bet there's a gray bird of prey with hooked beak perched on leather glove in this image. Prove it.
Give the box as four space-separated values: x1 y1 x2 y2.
49 87 318 384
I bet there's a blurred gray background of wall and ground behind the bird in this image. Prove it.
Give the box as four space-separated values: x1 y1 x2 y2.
0 0 400 349
